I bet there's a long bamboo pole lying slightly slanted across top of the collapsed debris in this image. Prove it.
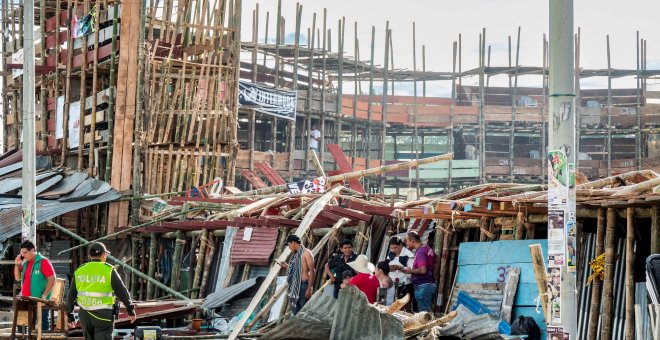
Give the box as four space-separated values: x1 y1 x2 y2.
232 153 454 197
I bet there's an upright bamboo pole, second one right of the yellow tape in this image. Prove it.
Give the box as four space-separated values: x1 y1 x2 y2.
626 208 635 340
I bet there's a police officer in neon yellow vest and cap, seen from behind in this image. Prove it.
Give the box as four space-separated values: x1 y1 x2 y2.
66 242 136 340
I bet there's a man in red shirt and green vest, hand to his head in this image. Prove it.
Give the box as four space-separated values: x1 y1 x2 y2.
14 241 55 330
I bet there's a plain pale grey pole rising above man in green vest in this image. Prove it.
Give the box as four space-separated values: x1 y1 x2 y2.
21 1 36 242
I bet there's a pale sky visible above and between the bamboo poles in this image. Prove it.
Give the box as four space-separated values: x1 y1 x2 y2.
242 0 660 96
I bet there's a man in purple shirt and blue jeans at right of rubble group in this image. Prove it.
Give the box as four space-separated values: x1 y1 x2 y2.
402 232 436 312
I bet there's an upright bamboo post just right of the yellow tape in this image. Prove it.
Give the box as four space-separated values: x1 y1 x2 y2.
601 208 616 340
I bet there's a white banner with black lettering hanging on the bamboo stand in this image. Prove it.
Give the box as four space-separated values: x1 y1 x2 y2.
238 80 298 121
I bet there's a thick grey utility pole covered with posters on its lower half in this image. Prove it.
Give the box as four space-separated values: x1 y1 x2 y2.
544 0 578 339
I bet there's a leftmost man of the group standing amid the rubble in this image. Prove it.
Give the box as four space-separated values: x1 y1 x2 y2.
280 235 316 315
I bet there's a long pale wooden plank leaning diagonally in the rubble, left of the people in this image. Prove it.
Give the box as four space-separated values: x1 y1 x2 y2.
229 185 344 340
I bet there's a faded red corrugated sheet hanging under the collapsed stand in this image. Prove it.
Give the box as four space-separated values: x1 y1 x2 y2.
231 227 278 265
